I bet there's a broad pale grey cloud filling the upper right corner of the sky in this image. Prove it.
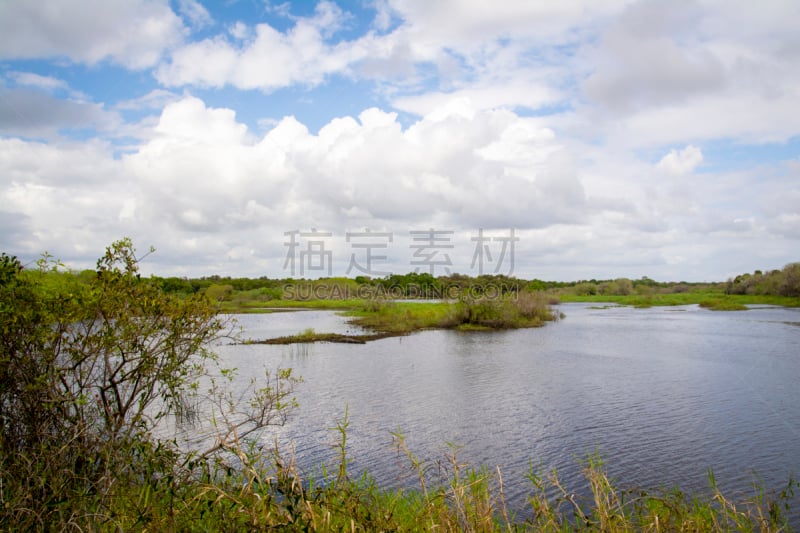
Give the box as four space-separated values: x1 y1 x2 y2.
576 0 800 148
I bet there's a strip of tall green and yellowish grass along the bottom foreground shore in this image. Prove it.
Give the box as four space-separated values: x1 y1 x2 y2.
9 422 799 533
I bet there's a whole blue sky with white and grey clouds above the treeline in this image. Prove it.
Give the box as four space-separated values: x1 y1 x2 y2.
0 0 800 281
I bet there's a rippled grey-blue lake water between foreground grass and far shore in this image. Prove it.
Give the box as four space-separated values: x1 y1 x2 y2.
212 304 800 508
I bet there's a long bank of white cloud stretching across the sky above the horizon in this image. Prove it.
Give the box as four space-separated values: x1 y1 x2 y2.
0 91 797 280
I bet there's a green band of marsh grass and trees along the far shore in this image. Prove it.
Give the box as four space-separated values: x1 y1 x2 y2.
147 263 800 316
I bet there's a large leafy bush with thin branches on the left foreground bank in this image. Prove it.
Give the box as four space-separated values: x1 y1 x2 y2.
0 239 294 529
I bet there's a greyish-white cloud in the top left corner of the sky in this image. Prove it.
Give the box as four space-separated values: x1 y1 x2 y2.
0 0 183 69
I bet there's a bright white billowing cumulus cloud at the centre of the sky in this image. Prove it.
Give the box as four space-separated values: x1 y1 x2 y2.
126 97 585 237
